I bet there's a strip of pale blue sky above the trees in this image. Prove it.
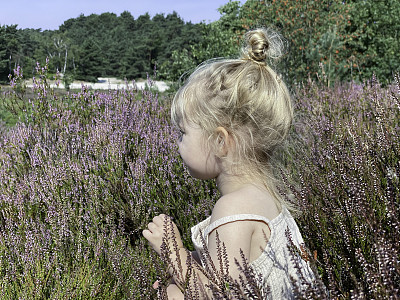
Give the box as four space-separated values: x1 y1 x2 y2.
0 0 244 30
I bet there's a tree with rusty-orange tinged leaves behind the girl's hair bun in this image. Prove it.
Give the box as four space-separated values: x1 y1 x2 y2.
234 0 350 84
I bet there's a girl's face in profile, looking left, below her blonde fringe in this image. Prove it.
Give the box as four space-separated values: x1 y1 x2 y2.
178 122 221 179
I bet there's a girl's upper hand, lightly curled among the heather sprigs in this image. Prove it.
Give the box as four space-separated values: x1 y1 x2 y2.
143 214 183 254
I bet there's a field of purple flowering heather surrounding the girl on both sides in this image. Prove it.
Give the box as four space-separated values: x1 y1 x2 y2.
0 62 400 299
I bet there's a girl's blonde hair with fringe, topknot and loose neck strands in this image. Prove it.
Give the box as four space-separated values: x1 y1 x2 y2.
171 28 293 210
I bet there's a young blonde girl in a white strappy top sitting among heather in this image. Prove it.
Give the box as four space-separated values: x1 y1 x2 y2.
143 29 313 299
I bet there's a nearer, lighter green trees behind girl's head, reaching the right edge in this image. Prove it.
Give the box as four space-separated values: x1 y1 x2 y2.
161 0 400 86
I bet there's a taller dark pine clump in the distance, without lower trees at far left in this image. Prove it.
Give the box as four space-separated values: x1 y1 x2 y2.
56 11 200 80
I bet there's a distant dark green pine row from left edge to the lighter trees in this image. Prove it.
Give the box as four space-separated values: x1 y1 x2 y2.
0 11 201 81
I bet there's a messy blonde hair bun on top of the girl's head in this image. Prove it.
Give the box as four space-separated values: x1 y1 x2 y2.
242 28 285 64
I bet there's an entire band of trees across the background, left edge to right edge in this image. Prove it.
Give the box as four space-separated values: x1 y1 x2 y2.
0 0 400 85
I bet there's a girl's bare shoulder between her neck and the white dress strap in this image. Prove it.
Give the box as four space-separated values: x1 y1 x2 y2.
211 186 279 222
